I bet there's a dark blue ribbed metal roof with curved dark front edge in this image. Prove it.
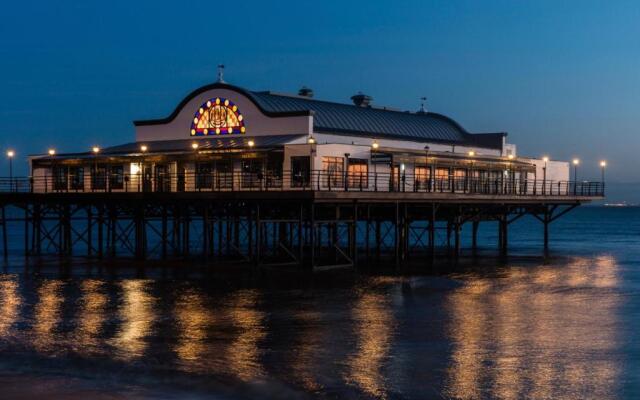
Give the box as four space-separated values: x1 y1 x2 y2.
134 83 506 149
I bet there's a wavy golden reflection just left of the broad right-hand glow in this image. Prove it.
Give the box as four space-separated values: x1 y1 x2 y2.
346 292 394 398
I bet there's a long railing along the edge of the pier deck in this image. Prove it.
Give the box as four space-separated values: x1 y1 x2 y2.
0 171 604 197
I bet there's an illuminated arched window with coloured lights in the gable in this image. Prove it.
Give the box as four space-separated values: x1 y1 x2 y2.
191 97 245 136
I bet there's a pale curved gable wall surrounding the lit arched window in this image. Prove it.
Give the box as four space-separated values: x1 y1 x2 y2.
136 89 313 142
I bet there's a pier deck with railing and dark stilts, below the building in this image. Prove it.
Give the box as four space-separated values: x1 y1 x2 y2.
0 171 604 271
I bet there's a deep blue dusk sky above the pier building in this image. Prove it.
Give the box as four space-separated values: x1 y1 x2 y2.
0 0 640 182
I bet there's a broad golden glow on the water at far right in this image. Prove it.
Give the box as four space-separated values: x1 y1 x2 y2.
444 256 620 399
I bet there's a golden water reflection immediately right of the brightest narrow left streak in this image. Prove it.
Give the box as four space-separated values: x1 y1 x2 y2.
174 289 214 372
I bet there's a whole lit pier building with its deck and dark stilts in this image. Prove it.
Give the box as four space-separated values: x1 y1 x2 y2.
0 75 604 270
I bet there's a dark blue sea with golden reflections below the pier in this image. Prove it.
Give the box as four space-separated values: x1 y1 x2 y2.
0 207 640 399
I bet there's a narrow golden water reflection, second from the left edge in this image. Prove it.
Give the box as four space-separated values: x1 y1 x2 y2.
32 280 64 352
